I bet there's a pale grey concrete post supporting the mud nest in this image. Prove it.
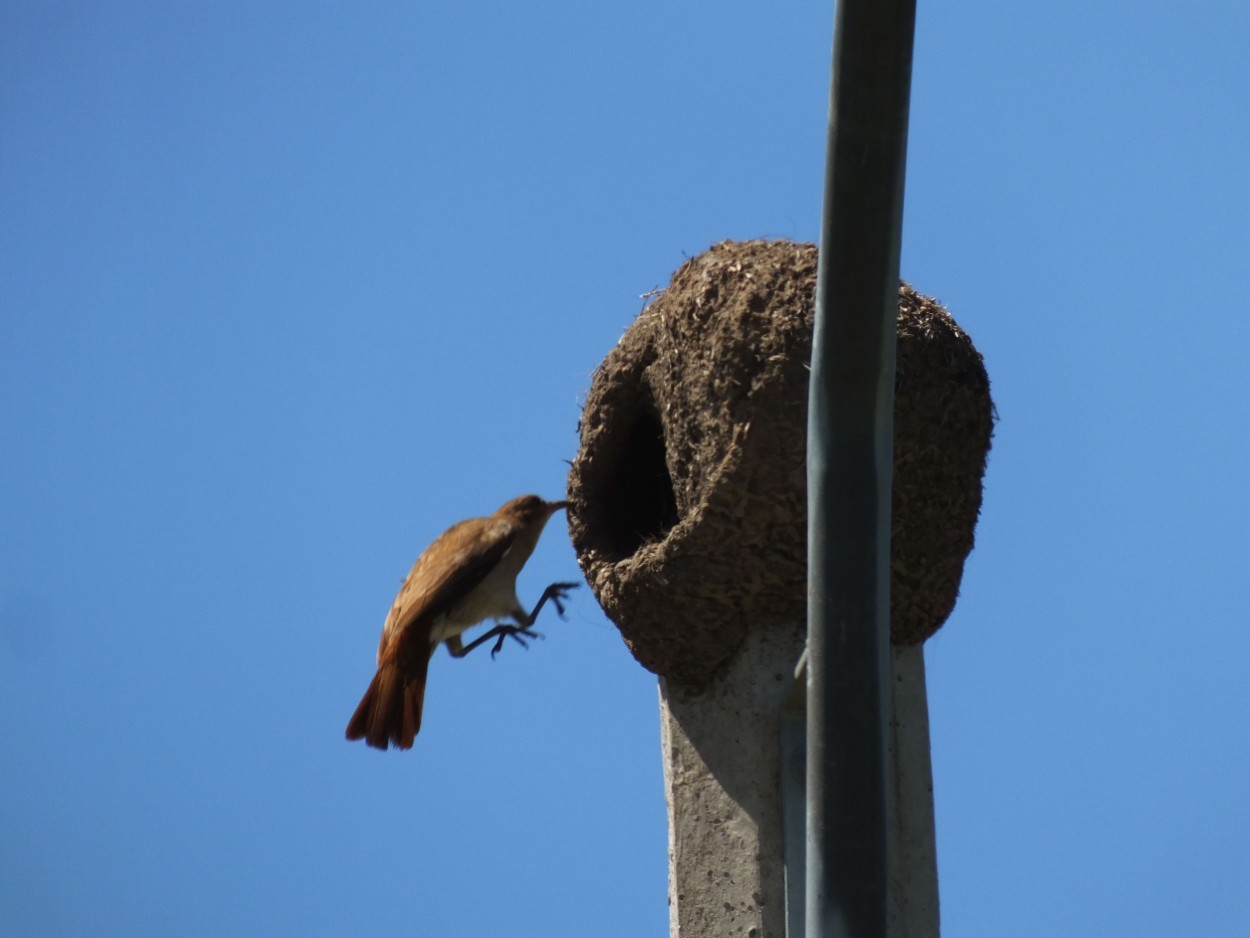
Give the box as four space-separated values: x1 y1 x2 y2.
660 635 939 938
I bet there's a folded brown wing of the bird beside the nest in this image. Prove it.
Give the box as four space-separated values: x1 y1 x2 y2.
378 518 516 662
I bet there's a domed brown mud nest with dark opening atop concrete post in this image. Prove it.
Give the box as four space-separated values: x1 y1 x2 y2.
568 241 994 690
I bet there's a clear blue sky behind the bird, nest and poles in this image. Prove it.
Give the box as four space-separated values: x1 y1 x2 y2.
0 0 1250 938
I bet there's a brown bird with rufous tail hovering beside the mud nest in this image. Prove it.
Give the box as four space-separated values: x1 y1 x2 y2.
346 495 579 749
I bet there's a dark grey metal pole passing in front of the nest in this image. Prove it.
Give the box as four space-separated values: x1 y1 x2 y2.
806 0 915 938
